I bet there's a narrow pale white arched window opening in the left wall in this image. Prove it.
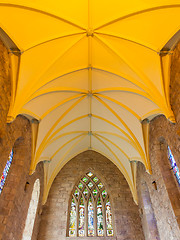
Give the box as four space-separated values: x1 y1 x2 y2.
22 179 40 240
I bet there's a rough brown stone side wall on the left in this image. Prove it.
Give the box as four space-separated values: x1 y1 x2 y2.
0 41 43 240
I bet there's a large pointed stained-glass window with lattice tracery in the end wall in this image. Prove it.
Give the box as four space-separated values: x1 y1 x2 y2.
68 172 114 237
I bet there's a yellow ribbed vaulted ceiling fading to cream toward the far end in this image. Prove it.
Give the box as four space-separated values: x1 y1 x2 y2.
0 0 180 201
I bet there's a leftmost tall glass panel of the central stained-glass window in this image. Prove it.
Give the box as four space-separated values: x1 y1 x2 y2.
69 198 76 237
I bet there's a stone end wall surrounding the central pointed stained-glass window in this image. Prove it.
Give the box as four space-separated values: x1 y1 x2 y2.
38 151 144 240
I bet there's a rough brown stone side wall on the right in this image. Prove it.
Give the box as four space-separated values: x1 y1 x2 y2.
137 40 180 240
